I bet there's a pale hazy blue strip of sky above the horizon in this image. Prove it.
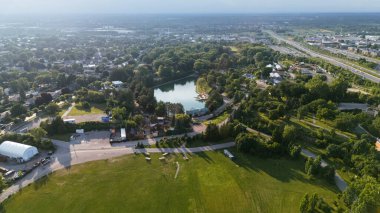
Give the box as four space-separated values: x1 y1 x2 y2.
0 0 380 15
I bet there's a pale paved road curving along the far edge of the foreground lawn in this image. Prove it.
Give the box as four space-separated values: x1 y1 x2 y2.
0 141 235 202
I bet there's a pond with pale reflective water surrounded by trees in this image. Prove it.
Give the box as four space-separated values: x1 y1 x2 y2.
154 77 205 111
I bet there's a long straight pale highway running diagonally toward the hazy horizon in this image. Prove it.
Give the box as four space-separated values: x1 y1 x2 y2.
264 31 380 83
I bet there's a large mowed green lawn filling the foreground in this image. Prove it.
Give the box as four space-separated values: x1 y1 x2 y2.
4 152 337 213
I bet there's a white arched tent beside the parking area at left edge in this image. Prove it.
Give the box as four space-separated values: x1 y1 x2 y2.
0 141 38 161
